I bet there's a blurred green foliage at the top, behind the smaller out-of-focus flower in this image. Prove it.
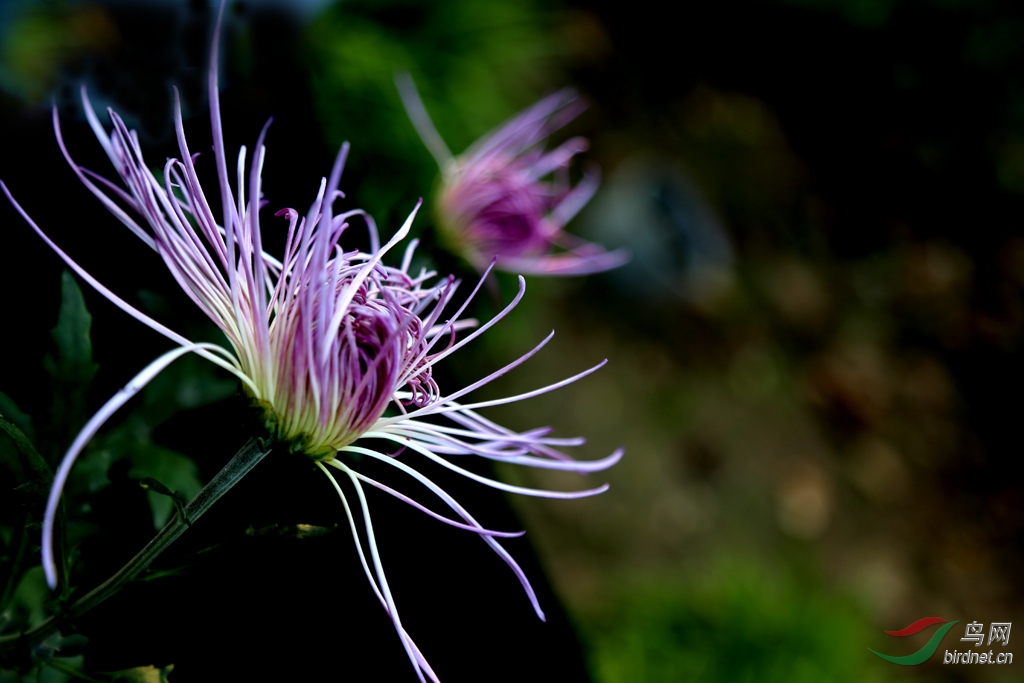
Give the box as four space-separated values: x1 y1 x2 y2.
305 0 560 234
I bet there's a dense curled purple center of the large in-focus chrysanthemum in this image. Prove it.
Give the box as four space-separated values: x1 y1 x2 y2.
258 278 437 460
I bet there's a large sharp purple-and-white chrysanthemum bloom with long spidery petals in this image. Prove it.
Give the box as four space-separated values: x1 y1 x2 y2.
0 6 622 681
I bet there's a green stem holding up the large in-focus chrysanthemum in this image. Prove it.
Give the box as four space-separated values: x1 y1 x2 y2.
0 438 270 650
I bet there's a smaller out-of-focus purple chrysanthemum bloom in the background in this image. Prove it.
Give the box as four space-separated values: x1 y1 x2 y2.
396 74 629 275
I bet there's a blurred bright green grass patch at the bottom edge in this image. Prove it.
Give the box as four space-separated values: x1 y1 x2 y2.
584 563 891 683
